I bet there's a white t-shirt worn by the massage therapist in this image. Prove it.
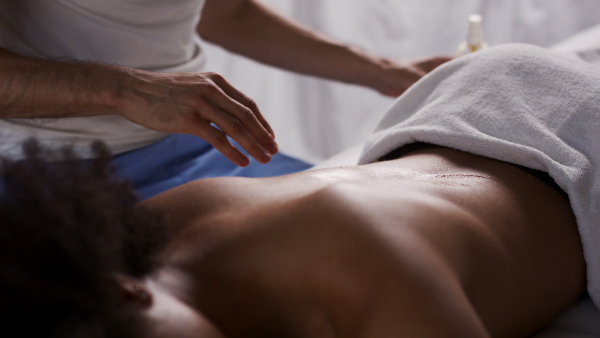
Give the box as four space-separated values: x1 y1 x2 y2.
0 0 205 157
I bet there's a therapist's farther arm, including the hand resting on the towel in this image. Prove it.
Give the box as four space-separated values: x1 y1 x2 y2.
198 0 448 95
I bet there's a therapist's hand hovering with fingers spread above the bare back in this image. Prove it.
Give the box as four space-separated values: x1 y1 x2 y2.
120 70 278 166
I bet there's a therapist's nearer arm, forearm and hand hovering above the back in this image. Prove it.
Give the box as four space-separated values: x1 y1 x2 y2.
0 48 277 166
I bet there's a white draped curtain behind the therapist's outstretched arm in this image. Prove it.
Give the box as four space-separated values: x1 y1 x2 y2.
200 0 600 162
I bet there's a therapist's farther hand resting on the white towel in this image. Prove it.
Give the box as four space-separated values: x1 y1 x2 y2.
371 56 452 97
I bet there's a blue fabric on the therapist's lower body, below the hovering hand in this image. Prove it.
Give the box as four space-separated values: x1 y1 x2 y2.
113 134 311 200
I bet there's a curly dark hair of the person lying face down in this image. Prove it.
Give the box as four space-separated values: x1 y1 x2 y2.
0 140 168 338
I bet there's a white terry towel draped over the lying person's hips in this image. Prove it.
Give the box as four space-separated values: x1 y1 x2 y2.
360 44 600 307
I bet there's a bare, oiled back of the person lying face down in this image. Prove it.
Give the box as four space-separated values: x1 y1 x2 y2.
144 148 585 337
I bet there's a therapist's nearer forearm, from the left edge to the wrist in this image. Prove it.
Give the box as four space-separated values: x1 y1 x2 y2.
0 48 125 118
